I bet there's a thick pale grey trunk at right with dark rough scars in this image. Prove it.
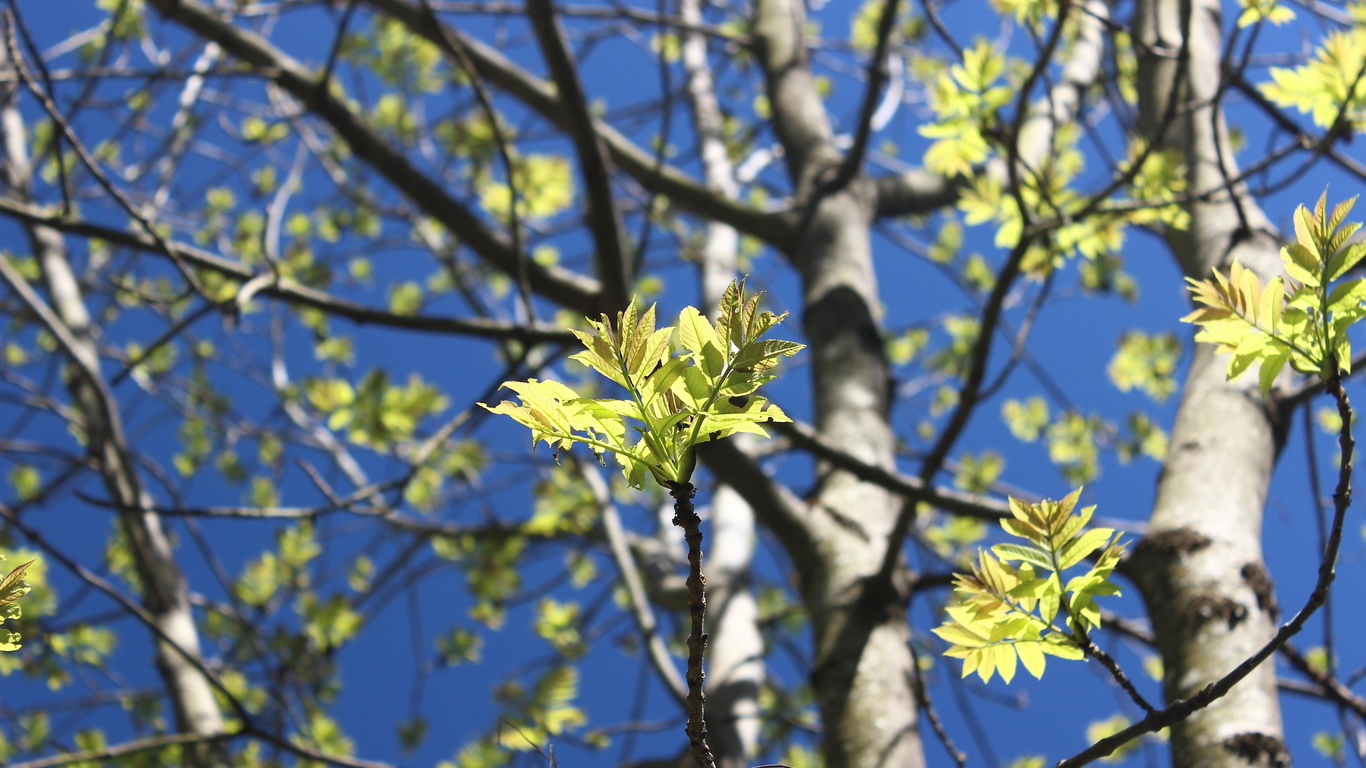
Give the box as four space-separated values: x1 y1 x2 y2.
1128 0 1287 768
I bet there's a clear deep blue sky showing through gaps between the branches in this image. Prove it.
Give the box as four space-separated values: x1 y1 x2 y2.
0 0 1366 767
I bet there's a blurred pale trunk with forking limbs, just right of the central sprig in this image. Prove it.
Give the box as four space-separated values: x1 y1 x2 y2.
754 0 925 768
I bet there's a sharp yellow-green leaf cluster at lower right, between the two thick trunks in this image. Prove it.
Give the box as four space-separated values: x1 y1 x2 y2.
934 489 1123 682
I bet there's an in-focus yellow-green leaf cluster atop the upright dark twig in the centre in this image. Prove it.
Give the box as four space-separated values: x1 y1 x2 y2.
479 280 805 488
